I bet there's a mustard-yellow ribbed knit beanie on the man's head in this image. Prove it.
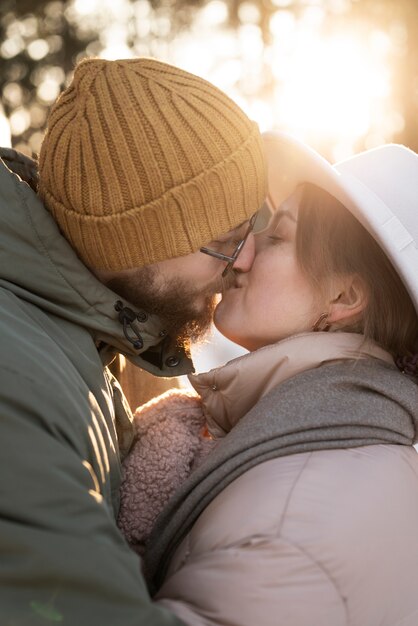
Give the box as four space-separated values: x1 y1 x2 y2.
39 58 266 270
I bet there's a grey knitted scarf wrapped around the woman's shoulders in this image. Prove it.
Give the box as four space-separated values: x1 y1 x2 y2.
145 359 418 592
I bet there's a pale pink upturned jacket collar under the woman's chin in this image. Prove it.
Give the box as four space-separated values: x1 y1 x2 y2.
189 332 393 438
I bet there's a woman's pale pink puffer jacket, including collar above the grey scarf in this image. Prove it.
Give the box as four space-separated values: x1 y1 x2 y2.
156 333 418 626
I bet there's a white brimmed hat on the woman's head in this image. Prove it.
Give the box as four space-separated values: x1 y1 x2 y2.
263 132 418 312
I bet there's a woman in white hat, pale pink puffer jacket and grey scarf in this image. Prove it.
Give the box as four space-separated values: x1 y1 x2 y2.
119 134 418 626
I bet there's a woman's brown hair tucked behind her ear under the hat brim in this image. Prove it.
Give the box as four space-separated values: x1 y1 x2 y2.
296 183 418 356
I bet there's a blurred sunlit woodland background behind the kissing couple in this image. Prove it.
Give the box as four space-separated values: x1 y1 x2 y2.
0 0 418 367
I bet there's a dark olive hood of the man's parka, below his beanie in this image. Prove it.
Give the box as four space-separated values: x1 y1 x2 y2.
0 159 193 376
